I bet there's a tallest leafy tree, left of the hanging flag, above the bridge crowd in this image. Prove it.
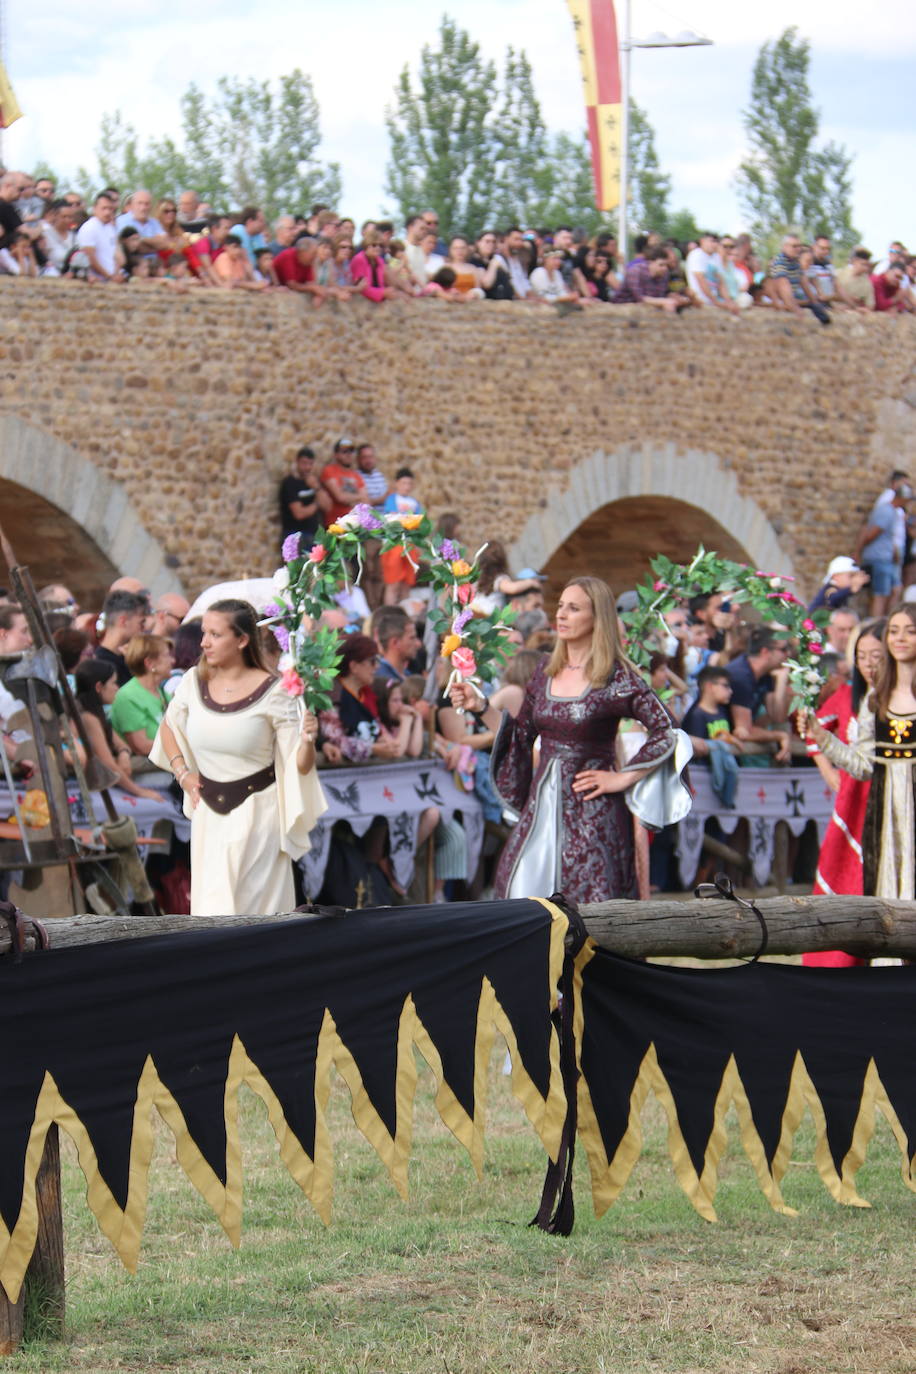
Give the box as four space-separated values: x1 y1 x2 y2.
385 15 497 235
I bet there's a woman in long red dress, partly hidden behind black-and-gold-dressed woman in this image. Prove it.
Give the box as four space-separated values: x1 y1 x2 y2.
802 620 884 969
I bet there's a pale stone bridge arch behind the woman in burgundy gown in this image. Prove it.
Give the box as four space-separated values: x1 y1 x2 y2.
509 444 794 585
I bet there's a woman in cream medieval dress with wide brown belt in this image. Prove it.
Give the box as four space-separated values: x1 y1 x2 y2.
150 600 327 916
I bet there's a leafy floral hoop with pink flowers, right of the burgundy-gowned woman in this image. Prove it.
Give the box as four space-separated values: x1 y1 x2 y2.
622 544 829 712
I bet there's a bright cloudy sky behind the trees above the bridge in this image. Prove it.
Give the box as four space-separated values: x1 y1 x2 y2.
3 0 916 250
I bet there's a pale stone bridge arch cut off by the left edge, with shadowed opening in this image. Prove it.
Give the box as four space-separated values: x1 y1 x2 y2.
0 415 184 605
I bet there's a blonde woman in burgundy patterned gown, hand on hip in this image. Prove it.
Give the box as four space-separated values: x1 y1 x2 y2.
452 577 674 903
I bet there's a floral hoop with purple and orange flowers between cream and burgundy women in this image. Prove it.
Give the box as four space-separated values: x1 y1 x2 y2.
260 503 515 712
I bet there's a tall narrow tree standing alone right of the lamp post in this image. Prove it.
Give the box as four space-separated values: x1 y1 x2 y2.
737 27 857 246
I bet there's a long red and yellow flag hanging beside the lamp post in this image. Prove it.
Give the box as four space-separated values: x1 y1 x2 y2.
567 0 621 210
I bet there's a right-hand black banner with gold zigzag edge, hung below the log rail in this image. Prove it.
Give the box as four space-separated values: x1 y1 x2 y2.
577 944 916 1220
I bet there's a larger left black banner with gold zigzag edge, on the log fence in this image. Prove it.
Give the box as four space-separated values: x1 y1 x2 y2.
0 901 567 1301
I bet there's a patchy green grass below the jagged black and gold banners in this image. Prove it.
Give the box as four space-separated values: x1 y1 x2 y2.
5 1054 916 1374
